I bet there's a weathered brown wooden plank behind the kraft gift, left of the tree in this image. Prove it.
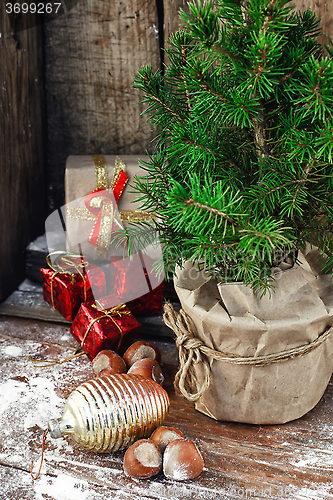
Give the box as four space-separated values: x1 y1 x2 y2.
46 0 160 209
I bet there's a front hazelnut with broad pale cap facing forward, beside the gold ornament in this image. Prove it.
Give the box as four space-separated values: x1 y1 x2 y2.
124 439 162 479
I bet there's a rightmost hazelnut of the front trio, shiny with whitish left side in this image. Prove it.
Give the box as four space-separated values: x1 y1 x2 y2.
163 439 205 481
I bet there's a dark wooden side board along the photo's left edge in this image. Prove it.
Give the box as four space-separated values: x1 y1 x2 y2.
0 7 45 301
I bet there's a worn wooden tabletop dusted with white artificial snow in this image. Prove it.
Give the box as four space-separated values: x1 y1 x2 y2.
0 316 333 500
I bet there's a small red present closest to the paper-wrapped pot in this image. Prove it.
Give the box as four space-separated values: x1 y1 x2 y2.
108 252 165 316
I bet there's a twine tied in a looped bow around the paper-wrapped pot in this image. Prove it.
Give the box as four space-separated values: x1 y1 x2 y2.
163 303 333 401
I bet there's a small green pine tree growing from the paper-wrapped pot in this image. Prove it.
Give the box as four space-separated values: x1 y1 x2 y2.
128 0 333 293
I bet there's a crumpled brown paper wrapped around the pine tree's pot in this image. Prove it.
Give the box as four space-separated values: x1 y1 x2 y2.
175 244 333 424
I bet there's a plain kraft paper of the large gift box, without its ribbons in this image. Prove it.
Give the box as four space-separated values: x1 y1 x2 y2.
65 155 148 259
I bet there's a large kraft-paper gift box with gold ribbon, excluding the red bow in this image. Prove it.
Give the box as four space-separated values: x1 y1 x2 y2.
65 155 150 260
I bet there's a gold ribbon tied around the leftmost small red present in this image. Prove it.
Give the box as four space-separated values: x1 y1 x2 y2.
46 250 88 309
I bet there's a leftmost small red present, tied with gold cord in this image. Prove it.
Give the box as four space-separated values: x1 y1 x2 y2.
41 252 106 321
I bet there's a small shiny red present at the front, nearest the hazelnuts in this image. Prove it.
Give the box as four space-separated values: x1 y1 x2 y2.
70 299 141 360
